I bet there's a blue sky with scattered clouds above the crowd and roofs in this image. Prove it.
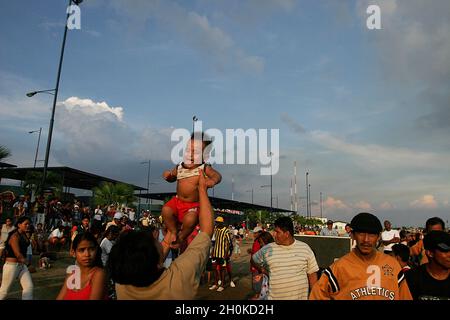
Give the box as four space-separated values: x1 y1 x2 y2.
0 0 450 226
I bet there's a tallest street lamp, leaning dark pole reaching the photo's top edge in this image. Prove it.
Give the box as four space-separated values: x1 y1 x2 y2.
27 0 83 192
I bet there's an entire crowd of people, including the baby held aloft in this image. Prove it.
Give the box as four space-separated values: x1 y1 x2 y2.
0 131 450 300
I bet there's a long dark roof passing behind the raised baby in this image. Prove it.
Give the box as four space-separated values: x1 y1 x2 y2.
136 192 295 213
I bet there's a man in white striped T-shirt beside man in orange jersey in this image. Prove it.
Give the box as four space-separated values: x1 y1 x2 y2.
253 217 319 300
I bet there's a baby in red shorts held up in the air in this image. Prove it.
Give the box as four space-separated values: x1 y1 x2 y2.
162 133 222 249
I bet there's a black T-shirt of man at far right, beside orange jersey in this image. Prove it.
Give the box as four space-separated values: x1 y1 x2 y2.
405 264 450 300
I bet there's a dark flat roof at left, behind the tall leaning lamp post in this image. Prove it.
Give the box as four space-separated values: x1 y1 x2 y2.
0 167 147 190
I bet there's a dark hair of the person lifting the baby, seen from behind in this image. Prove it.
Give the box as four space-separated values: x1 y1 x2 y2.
107 231 164 287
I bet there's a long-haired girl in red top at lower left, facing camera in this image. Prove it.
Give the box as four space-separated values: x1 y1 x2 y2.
56 232 107 300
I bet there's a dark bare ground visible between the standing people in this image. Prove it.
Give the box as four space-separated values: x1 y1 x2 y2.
0 240 252 300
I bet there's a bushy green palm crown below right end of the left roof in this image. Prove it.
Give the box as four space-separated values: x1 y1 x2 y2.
92 182 136 206
